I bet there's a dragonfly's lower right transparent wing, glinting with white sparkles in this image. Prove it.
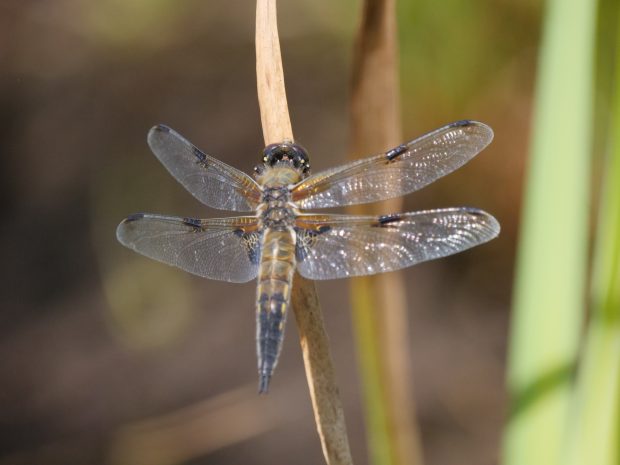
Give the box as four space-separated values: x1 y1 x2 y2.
296 208 500 279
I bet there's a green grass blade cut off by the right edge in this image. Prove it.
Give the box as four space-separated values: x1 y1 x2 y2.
564 4 620 465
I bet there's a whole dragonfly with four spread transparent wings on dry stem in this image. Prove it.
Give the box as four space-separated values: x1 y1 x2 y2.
116 120 500 393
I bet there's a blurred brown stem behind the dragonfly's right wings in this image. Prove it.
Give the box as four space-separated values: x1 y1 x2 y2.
351 0 422 465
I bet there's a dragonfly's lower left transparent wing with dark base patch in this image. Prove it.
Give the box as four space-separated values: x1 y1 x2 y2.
116 213 260 283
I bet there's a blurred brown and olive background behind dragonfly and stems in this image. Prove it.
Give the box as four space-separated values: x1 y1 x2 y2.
0 0 541 465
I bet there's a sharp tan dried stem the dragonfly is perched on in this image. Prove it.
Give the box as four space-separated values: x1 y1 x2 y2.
256 0 353 465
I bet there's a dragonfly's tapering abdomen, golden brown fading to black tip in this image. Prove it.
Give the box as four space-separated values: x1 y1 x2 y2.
256 229 295 393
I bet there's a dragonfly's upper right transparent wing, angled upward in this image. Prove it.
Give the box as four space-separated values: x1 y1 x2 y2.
292 121 493 209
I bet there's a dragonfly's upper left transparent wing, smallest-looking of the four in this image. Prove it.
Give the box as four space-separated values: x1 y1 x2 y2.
148 124 261 211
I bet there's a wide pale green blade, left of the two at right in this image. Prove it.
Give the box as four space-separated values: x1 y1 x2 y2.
503 0 596 465
